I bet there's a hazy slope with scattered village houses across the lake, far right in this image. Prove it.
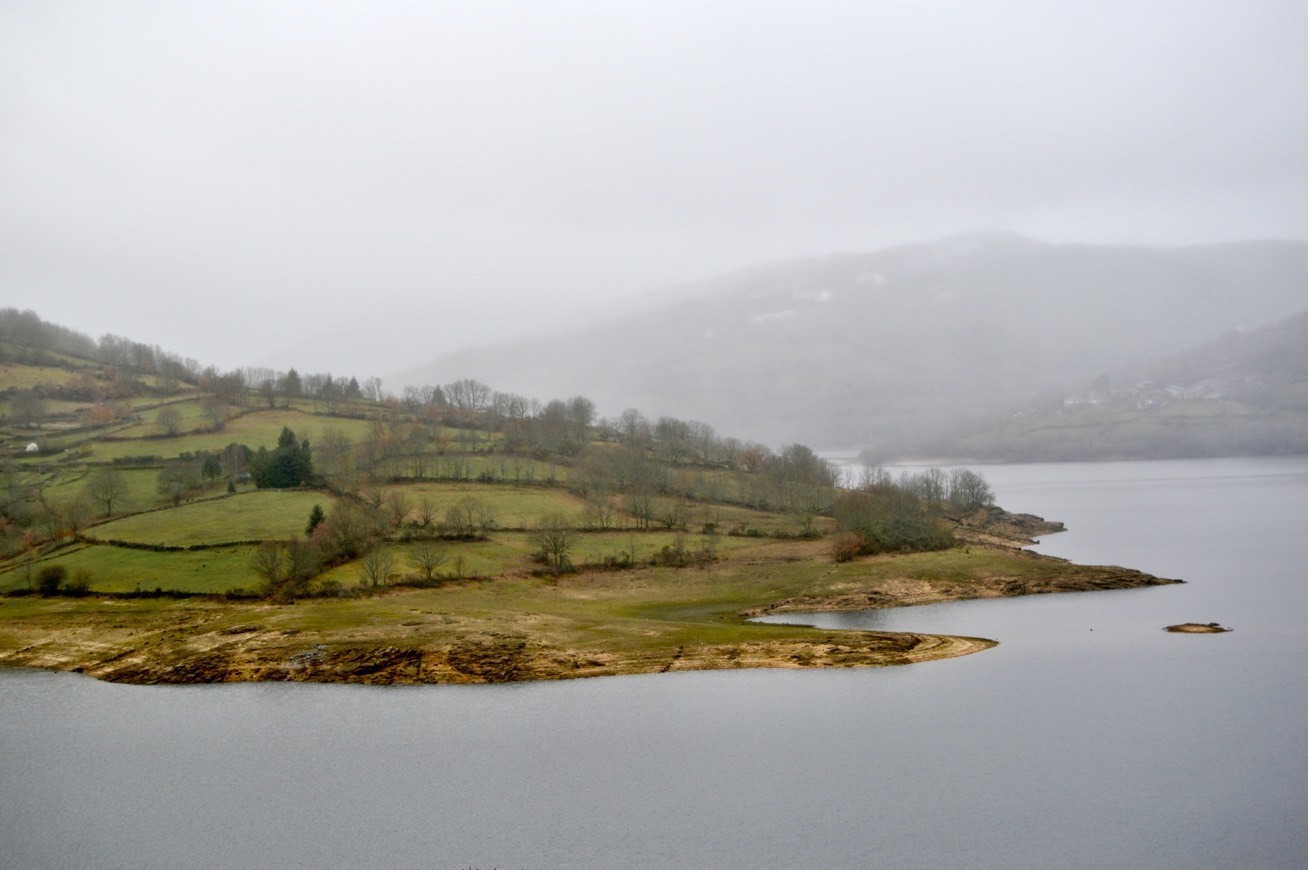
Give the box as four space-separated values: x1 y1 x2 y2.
915 304 1308 462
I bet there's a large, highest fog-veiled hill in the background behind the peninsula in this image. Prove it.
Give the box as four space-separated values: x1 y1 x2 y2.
402 233 1308 446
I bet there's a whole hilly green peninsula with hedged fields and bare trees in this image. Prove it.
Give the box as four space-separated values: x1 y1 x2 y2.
0 310 1173 683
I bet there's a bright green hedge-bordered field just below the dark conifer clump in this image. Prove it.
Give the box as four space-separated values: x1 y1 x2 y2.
86 491 332 547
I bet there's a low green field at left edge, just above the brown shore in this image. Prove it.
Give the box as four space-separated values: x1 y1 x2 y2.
0 544 259 593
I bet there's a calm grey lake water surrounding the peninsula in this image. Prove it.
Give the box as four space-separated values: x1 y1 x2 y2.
0 458 1308 869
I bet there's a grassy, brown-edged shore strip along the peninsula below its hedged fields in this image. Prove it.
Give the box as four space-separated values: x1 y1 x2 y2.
0 508 1182 684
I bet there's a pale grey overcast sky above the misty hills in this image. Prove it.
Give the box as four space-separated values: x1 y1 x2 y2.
0 0 1308 378
